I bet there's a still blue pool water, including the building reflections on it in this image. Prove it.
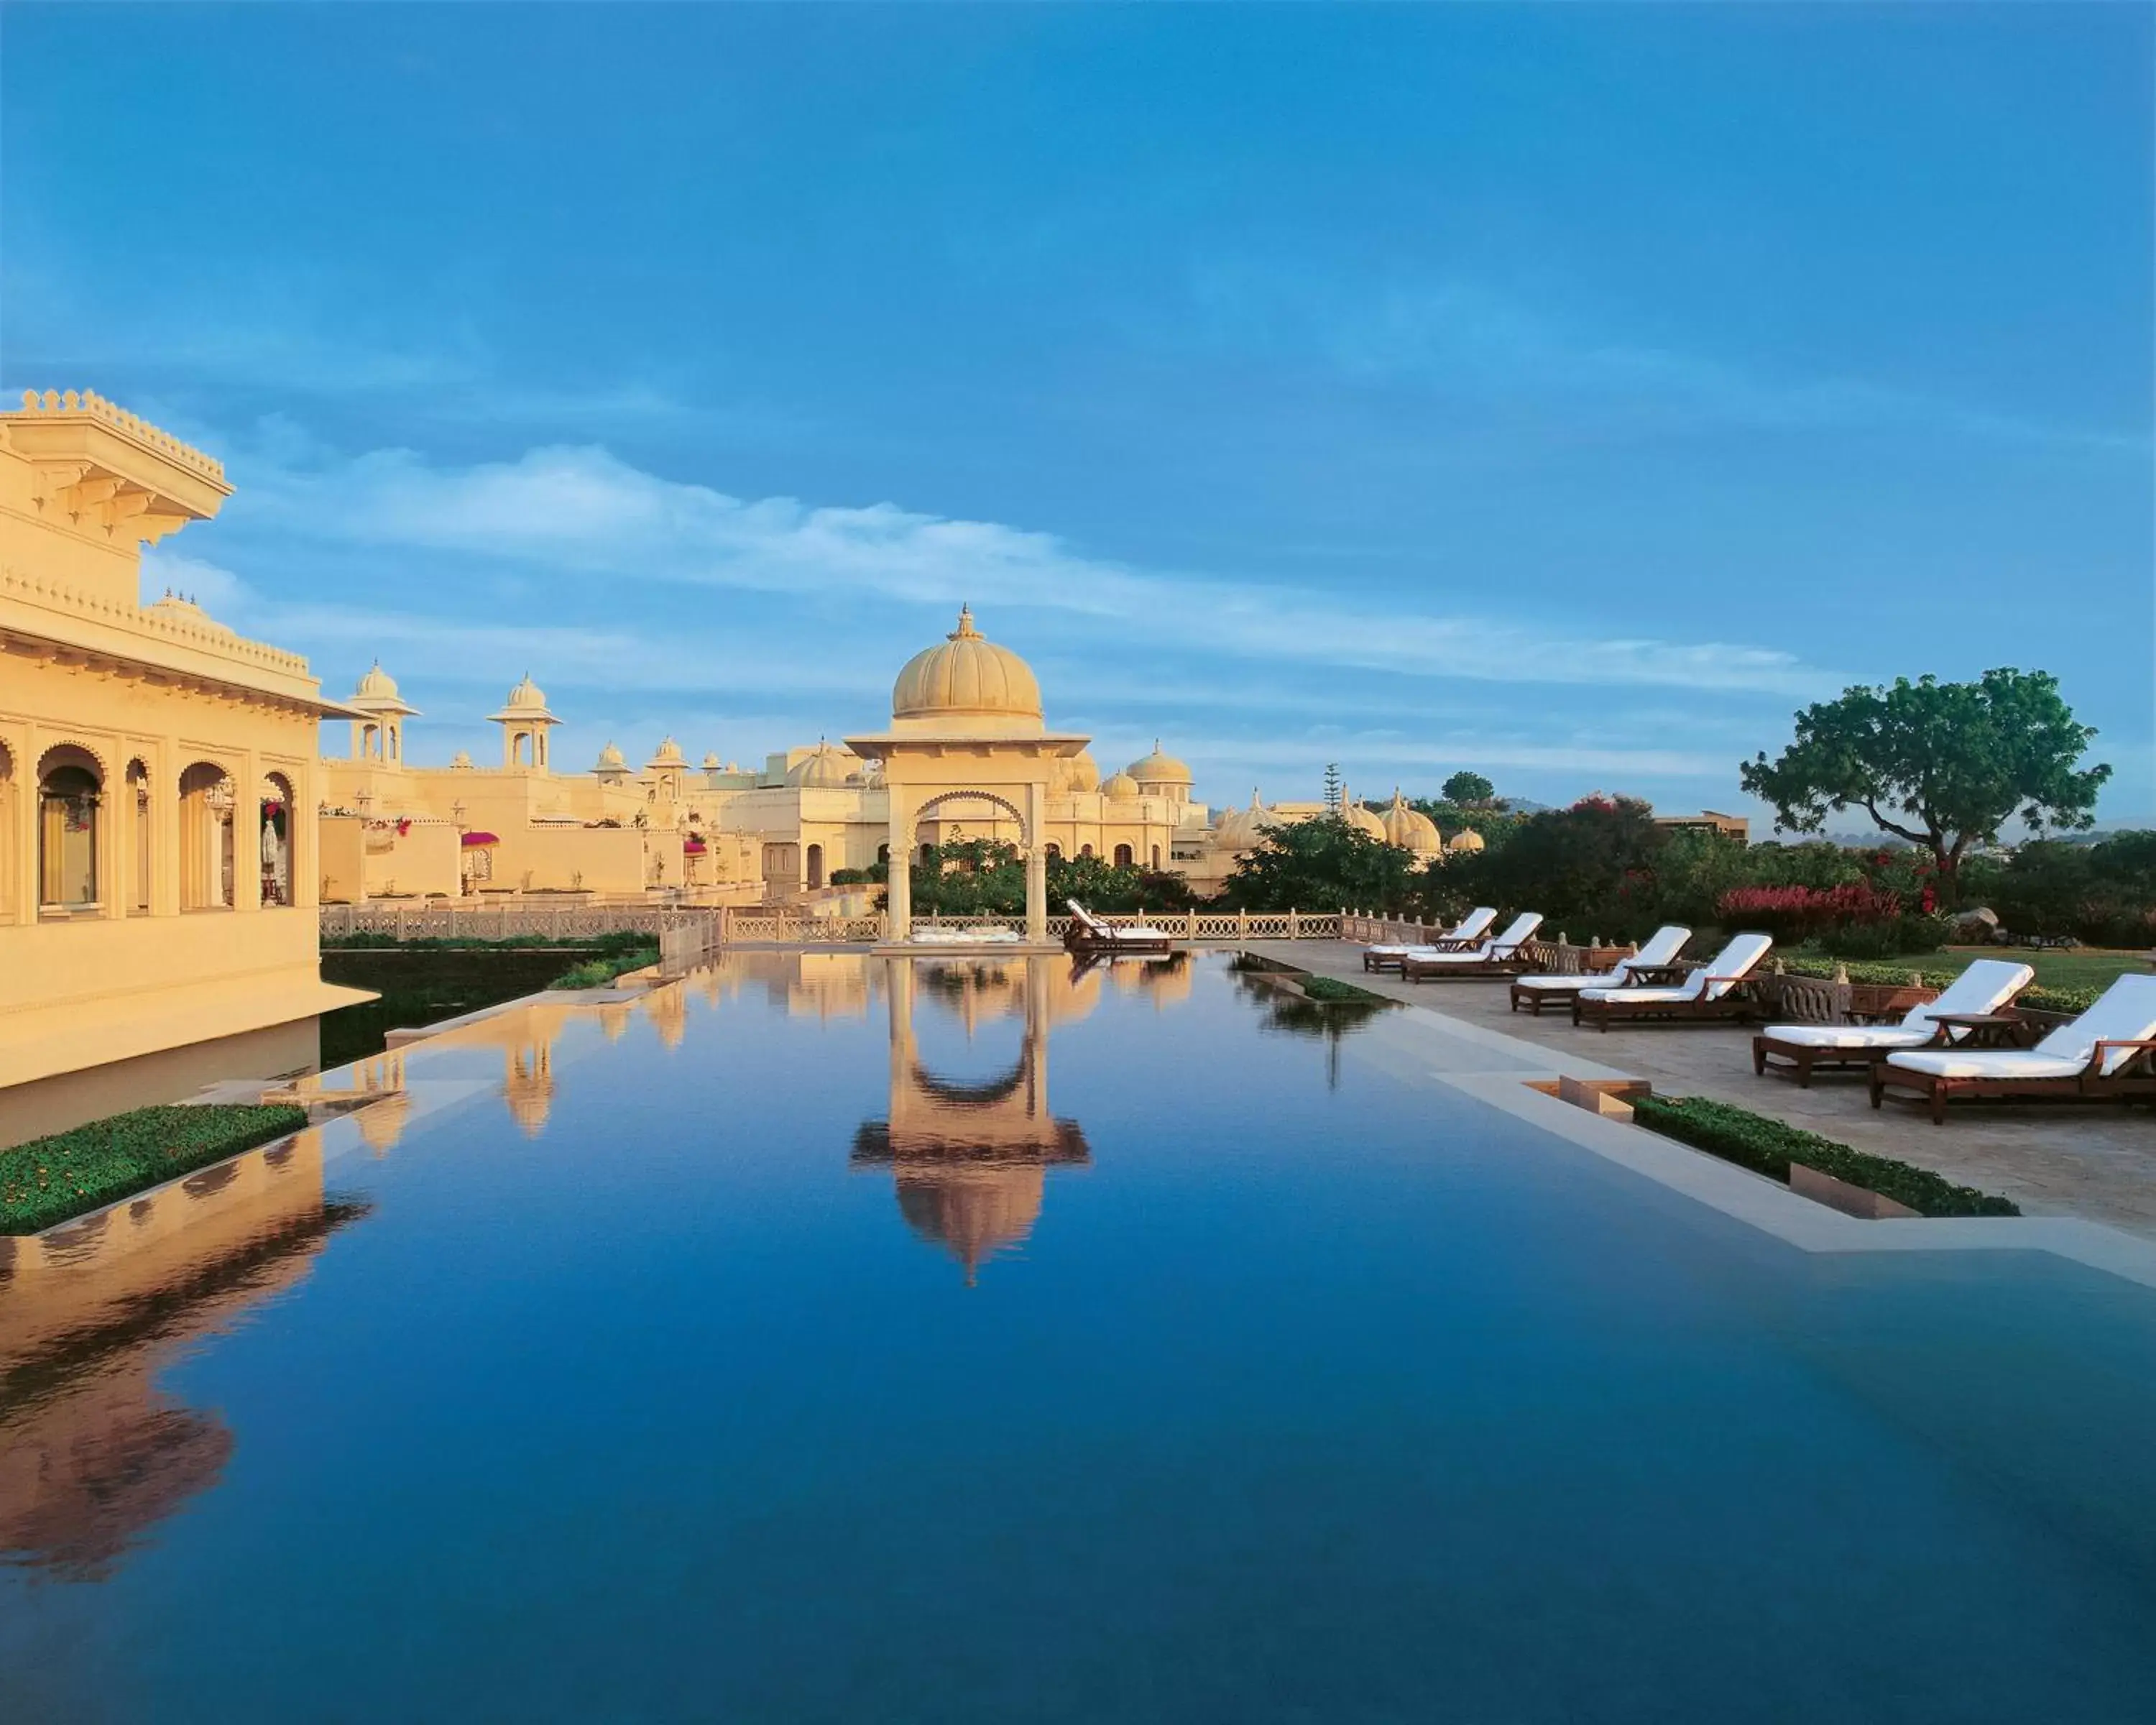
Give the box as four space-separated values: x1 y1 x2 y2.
0 953 2156 1725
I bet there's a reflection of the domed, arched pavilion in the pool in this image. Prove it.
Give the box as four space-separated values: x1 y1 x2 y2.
854 957 1100 1287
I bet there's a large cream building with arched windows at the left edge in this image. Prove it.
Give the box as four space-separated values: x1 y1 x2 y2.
0 392 369 1143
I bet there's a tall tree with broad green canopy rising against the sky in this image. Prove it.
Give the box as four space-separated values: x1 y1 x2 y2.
1738 666 2111 903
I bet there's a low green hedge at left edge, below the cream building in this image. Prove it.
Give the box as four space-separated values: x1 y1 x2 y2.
0 1102 306 1233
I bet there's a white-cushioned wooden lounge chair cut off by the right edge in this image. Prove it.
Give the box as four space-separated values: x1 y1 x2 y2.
1871 977 2156 1123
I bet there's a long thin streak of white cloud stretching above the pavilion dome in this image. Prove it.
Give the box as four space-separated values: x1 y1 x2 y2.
250 446 1835 694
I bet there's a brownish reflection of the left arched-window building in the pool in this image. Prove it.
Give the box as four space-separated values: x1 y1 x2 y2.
0 1130 367 1578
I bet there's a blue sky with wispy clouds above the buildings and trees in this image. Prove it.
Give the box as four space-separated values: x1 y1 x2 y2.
0 4 2156 819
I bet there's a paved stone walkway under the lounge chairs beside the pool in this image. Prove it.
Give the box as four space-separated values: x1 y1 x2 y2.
1250 940 2156 1238
